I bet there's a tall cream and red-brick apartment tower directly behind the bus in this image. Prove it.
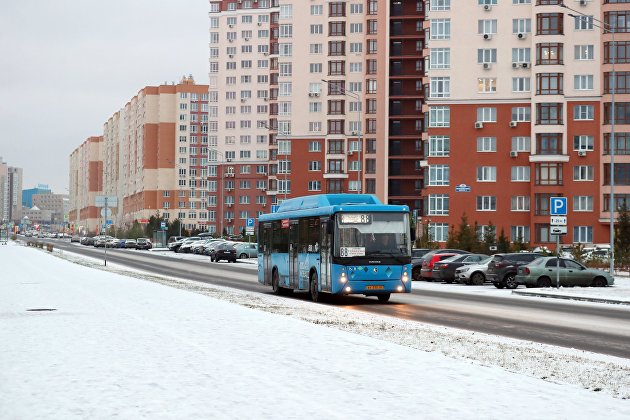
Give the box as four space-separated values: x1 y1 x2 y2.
209 0 424 231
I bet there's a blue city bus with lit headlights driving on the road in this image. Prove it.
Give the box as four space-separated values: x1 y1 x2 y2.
258 194 413 302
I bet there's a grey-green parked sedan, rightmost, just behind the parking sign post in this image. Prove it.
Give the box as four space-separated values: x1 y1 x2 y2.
516 257 615 287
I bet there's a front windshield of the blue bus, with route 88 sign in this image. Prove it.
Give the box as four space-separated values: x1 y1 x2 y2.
334 213 411 257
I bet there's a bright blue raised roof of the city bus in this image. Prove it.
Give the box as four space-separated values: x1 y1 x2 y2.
259 194 409 222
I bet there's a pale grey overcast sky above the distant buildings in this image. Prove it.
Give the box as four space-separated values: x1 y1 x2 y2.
0 0 208 193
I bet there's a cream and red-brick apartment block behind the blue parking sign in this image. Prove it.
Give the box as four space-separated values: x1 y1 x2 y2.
423 0 616 245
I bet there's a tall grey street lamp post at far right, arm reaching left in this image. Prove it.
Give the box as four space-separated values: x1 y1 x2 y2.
560 3 617 276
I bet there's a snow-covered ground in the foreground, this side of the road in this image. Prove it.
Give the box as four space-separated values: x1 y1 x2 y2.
0 241 630 419
